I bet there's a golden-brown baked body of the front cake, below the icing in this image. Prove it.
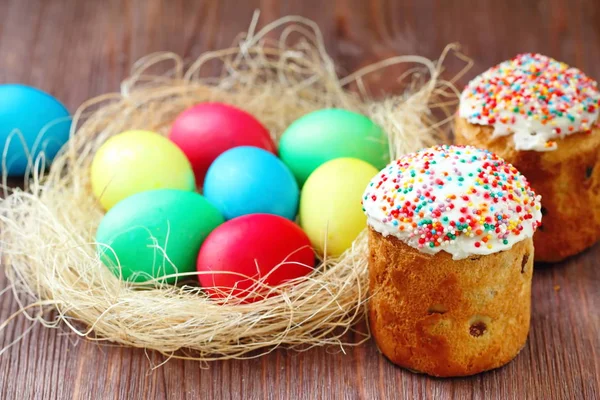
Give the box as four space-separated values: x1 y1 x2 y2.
368 229 534 377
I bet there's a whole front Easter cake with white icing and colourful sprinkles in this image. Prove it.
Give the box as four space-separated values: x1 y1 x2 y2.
362 145 541 377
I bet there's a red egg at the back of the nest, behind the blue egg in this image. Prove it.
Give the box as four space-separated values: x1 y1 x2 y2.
169 103 276 185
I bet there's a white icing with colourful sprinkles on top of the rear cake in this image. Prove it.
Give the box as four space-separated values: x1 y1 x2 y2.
459 54 600 151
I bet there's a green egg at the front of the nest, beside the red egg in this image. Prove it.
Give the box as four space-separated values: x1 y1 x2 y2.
96 189 223 283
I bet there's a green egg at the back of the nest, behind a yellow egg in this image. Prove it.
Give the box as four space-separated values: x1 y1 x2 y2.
279 108 390 186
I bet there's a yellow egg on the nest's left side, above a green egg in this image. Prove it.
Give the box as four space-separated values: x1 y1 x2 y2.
91 130 195 210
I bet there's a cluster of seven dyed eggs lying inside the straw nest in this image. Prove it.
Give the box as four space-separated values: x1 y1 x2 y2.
91 103 389 298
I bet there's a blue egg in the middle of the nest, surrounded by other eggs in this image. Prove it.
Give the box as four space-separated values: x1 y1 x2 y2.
204 146 300 220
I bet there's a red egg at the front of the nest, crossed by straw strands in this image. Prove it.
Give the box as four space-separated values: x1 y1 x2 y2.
197 214 314 301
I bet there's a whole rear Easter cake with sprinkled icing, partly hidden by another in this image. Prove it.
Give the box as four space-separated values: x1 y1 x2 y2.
455 54 600 262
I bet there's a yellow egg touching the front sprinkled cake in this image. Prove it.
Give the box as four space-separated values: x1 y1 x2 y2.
300 158 379 257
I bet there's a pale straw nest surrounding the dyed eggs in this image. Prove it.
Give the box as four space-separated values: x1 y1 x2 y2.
0 16 468 361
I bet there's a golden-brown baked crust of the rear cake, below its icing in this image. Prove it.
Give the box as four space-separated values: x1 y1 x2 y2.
455 114 600 262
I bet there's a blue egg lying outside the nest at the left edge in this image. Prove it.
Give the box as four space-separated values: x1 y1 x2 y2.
0 84 71 176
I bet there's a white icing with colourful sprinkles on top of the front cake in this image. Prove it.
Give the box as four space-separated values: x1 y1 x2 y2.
362 145 542 260
